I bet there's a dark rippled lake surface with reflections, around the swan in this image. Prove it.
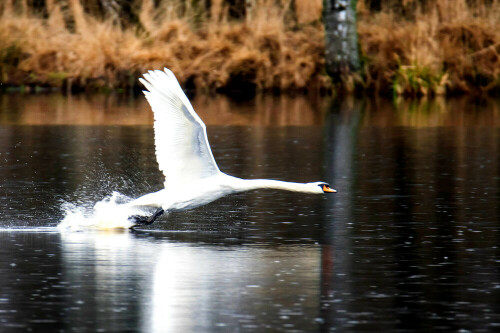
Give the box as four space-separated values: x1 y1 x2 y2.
0 95 500 332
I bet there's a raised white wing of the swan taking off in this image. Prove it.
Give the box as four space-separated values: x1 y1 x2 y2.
139 68 219 186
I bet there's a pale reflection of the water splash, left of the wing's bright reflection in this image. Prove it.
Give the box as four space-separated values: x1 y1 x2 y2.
61 232 151 331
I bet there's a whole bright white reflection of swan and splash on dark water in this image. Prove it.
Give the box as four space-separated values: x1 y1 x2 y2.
62 233 320 332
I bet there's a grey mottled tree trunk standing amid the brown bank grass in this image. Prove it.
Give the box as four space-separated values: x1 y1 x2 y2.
323 0 360 82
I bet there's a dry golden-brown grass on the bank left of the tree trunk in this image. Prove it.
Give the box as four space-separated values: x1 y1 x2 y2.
0 0 328 91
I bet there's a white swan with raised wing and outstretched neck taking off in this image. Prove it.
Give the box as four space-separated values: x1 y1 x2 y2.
126 68 336 228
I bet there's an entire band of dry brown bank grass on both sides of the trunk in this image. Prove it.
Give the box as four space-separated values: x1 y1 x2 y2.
0 0 500 96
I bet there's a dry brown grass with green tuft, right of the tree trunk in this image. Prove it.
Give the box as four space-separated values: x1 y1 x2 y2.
358 0 500 95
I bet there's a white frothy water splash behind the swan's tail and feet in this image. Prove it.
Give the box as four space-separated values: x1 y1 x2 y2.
57 192 149 231
